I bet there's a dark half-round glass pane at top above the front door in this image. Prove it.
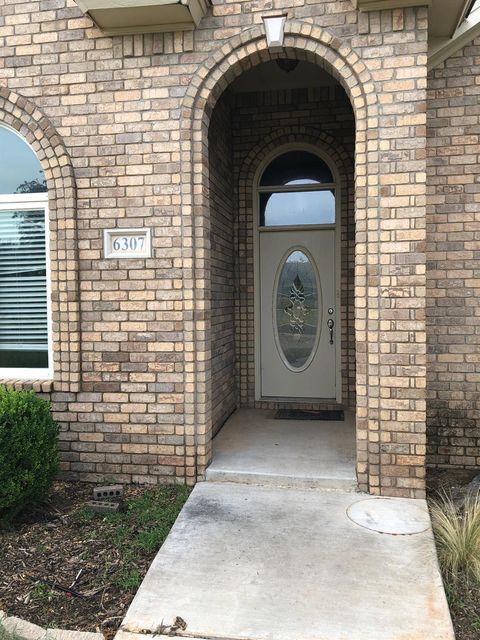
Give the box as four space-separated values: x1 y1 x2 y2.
260 151 334 187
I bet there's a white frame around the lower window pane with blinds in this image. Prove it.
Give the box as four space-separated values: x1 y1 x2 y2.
0 190 53 380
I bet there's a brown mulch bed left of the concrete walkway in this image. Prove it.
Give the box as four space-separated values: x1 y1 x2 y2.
0 482 187 639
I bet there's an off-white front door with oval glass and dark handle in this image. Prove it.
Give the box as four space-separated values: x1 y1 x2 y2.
258 228 338 400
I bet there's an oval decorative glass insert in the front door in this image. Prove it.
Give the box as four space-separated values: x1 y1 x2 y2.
274 249 321 371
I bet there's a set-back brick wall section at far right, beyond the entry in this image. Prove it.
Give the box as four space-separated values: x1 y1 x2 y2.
427 39 480 468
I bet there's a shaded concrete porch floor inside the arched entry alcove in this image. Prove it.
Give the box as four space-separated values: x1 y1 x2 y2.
206 409 356 490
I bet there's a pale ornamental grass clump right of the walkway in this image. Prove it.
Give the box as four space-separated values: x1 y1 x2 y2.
431 493 480 582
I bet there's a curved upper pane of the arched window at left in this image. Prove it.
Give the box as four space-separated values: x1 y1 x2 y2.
0 127 47 194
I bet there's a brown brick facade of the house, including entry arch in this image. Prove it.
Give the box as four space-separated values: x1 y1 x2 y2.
0 0 480 497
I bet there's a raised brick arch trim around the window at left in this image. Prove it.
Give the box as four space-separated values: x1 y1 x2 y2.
0 88 80 392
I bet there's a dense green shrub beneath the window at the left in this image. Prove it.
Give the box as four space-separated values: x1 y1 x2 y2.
0 387 58 523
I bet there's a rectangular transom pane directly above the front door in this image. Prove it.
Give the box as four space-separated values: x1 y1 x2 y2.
260 190 335 227
